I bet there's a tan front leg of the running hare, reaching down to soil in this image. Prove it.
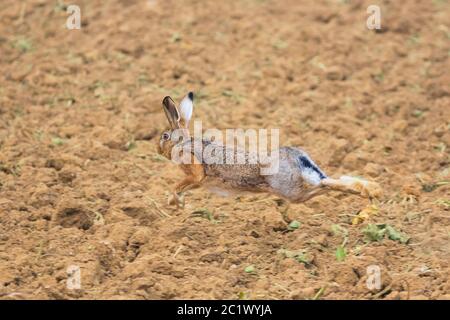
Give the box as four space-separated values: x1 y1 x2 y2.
168 164 205 208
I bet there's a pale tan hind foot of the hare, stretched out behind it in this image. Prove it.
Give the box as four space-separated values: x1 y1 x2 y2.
320 176 383 198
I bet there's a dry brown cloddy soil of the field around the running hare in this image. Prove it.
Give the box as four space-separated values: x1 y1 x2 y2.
0 0 450 299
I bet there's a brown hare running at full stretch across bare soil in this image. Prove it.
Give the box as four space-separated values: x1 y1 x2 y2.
158 92 382 207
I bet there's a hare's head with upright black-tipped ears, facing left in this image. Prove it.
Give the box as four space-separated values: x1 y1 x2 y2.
158 92 194 159
